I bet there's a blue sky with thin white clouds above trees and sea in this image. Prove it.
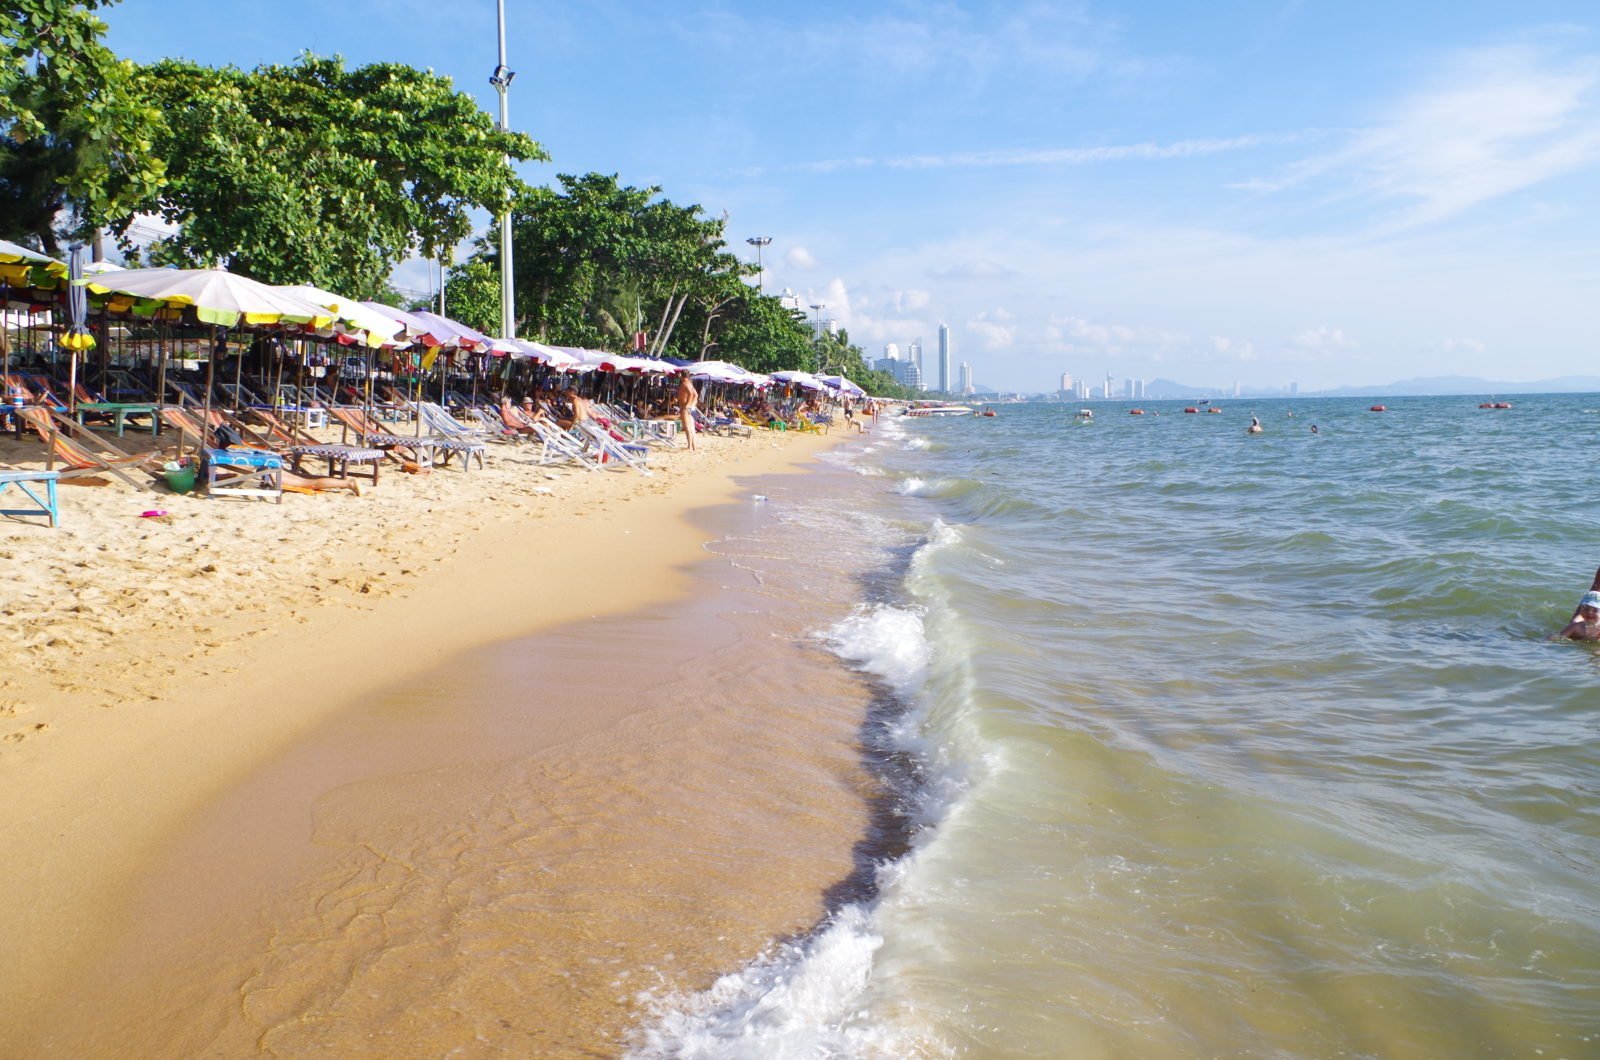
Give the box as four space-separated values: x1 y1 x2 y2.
106 0 1600 391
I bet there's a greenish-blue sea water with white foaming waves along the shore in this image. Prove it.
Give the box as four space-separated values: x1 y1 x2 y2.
634 395 1600 1057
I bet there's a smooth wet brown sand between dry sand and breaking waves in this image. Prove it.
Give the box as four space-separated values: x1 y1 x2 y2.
6 438 896 1057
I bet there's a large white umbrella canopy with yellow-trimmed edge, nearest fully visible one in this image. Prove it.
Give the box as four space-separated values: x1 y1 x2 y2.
80 269 338 328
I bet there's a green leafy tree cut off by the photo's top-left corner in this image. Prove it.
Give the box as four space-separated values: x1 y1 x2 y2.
0 0 165 253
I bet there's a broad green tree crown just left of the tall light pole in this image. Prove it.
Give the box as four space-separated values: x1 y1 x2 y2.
120 54 546 296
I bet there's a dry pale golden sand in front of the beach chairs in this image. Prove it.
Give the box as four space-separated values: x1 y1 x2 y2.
0 419 853 1055
